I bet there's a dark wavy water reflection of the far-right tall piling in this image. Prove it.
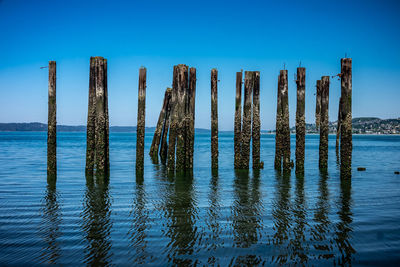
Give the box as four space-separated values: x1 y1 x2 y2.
335 175 356 265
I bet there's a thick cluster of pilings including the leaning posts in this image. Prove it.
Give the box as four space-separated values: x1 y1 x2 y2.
148 64 196 173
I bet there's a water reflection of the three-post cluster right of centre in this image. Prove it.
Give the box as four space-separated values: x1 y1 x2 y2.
230 170 263 266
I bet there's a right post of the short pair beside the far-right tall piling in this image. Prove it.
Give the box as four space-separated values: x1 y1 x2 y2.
319 76 329 170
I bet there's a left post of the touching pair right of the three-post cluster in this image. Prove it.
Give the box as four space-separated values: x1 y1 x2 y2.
274 73 282 170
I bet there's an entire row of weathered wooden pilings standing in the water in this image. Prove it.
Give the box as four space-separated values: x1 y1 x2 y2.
47 57 352 180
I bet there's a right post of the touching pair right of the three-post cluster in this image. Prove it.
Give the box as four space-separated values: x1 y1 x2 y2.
281 70 291 171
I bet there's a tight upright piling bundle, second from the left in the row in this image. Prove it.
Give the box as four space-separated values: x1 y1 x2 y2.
85 57 110 176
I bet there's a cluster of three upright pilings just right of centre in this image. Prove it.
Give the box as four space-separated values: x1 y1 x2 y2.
234 71 264 169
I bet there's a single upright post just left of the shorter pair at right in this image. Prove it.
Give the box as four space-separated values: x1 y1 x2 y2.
296 68 306 174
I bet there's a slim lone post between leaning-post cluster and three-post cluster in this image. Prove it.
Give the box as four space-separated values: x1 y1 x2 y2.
211 69 218 169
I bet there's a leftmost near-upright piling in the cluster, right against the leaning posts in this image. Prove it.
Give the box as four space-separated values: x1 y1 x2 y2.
167 66 178 174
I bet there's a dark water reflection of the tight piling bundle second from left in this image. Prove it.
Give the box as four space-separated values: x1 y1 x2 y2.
81 175 112 266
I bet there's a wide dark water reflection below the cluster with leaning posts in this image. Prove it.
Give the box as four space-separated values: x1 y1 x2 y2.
164 175 200 266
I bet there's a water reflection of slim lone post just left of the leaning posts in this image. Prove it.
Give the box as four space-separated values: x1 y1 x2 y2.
128 179 150 265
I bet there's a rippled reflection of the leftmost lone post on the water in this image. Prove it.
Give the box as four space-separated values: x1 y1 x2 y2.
39 175 62 265
